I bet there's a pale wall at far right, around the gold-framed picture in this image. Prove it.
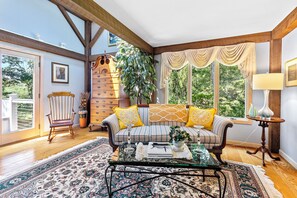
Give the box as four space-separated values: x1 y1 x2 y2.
280 29 297 168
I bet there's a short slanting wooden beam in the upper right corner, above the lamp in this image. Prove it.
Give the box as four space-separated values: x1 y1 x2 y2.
272 7 297 39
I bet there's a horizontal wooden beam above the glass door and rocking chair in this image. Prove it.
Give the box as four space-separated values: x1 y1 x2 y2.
0 30 86 61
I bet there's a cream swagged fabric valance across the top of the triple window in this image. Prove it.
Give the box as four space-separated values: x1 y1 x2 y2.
160 43 256 89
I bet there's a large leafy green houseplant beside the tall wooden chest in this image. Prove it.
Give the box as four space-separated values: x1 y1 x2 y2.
115 40 156 104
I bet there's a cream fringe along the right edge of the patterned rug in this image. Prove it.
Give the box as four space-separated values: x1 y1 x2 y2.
253 165 283 198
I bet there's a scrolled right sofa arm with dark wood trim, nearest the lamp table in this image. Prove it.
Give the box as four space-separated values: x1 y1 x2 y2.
212 115 233 147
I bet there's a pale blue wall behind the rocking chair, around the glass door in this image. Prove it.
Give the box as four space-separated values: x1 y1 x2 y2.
0 42 84 134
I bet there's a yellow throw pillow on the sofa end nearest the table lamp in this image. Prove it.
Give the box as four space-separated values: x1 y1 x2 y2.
186 106 216 130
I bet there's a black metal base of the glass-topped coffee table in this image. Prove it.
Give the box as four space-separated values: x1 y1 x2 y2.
105 165 227 197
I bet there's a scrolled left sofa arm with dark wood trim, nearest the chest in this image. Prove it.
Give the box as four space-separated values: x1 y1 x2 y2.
102 114 120 150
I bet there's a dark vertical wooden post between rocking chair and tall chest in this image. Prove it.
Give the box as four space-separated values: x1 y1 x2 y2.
85 20 92 124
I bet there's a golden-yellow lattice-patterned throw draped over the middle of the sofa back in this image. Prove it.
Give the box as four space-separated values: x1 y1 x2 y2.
149 104 188 122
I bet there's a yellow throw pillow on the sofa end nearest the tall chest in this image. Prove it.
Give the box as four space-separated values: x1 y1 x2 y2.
113 105 144 129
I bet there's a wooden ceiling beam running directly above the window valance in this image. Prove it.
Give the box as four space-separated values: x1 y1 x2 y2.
154 32 271 54
